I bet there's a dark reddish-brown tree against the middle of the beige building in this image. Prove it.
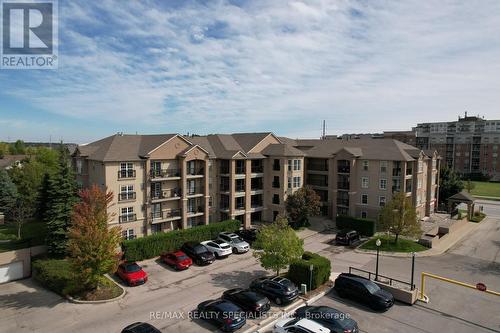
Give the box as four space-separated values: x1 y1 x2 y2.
285 186 320 228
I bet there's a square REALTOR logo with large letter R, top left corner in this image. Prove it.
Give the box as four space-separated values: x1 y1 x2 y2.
0 0 58 69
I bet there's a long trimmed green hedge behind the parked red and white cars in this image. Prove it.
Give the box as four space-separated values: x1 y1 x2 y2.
122 220 241 261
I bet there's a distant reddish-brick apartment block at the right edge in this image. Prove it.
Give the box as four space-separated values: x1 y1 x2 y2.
415 112 500 181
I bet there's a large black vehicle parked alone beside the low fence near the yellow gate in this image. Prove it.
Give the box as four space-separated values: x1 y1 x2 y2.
334 273 394 310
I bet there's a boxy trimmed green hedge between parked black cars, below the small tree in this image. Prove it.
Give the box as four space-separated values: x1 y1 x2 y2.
288 252 331 290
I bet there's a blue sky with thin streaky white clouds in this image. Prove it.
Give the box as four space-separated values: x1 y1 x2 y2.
0 0 500 143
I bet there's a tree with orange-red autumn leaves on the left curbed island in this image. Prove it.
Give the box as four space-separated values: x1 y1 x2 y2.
68 185 121 290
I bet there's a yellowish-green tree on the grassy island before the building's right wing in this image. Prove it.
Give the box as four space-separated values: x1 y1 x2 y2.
379 192 422 243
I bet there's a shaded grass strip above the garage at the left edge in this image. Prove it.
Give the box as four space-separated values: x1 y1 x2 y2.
0 222 47 252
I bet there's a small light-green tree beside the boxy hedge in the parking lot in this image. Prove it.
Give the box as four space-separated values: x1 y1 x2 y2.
254 216 304 275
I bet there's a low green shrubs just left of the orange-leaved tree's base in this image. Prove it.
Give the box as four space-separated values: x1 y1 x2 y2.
32 259 74 296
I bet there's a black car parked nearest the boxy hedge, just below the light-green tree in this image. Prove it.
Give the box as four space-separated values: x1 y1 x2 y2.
250 276 299 305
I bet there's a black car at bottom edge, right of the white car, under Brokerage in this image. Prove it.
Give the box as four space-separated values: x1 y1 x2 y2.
294 306 359 333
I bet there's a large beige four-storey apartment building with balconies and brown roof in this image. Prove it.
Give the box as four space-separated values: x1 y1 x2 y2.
72 133 439 238
